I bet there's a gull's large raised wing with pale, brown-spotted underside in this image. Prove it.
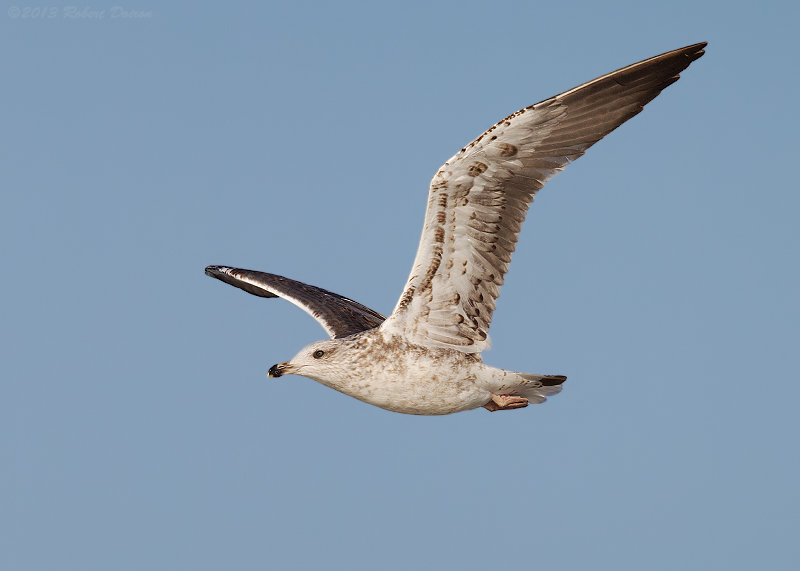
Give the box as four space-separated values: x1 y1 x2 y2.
383 43 706 353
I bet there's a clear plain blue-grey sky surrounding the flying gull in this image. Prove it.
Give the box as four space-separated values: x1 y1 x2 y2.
0 0 800 571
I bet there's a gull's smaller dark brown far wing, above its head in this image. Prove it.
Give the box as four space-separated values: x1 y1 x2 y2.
206 266 386 339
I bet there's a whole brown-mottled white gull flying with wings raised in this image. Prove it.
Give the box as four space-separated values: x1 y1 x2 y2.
206 42 706 415
